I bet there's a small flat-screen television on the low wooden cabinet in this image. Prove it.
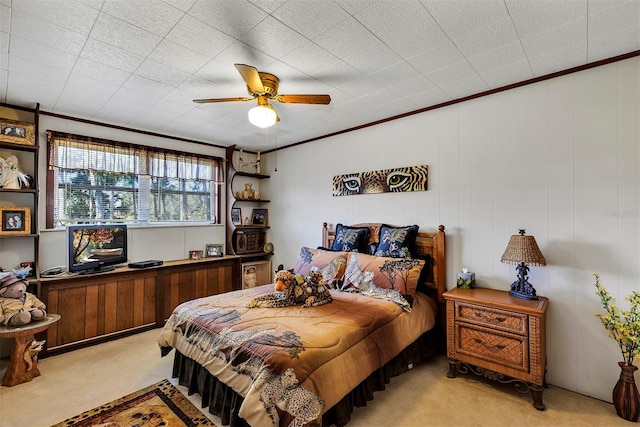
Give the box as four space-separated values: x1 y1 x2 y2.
67 224 128 274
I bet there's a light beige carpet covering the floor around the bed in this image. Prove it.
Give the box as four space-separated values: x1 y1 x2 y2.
0 329 637 427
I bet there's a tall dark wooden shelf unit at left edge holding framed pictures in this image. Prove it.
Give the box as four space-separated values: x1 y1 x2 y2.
0 104 40 284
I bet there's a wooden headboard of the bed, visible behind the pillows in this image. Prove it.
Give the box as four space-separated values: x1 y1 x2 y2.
322 222 447 304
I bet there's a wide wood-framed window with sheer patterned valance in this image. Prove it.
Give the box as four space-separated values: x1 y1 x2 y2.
47 131 223 228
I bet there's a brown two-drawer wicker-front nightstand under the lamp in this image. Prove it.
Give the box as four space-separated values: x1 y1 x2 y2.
444 288 549 411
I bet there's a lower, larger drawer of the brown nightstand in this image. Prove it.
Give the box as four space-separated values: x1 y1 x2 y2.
455 322 529 372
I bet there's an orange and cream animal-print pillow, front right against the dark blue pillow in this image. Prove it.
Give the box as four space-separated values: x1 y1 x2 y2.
342 253 425 297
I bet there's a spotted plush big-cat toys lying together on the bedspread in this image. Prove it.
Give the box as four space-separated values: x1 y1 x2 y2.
247 270 332 308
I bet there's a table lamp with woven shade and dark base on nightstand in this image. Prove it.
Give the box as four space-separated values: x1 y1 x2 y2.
500 229 547 299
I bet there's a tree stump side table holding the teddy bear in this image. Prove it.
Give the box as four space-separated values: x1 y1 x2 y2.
0 314 60 387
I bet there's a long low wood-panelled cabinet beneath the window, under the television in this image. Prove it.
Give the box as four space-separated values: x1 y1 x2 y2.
39 257 240 354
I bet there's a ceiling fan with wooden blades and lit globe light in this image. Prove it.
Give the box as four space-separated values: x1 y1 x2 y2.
193 64 331 128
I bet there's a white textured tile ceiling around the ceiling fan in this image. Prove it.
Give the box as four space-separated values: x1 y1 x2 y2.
0 0 640 150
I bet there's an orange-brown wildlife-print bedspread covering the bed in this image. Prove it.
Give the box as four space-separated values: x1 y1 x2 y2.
158 285 435 426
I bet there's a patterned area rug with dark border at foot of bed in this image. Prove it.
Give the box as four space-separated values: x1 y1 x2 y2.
52 380 215 427
